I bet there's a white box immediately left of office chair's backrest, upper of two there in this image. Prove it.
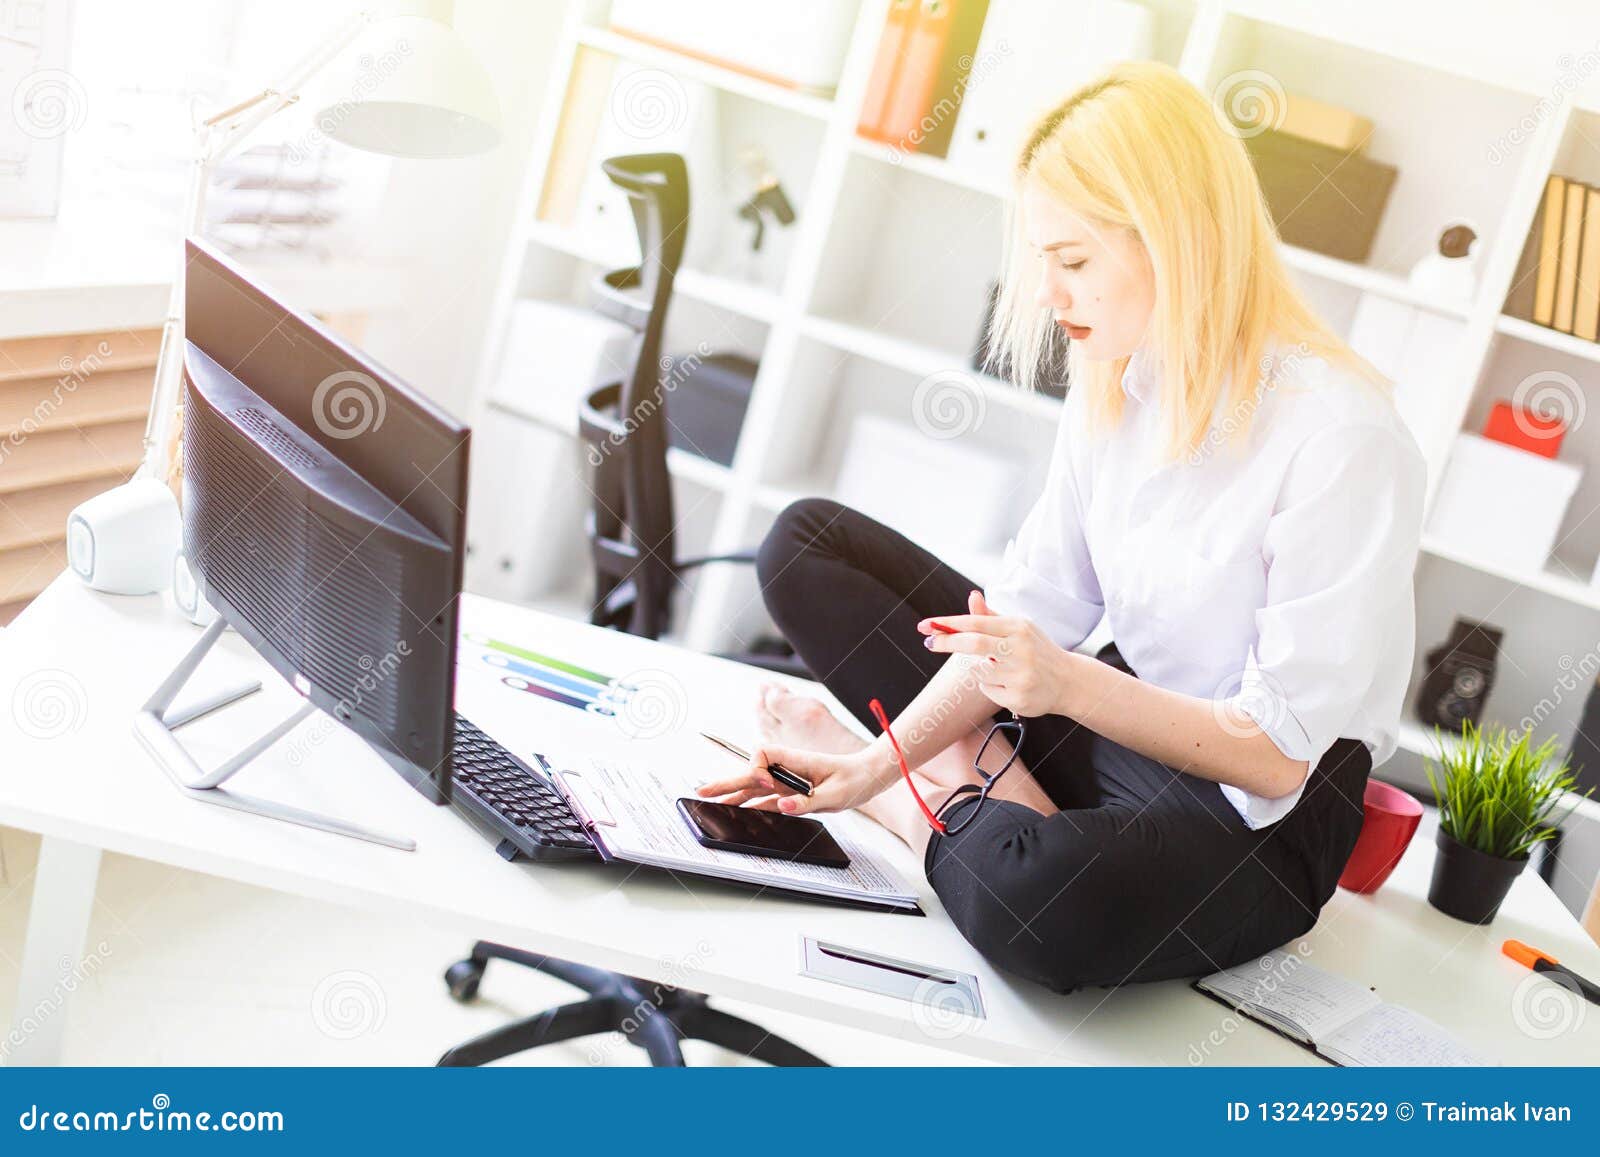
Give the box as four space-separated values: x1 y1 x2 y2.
490 299 637 429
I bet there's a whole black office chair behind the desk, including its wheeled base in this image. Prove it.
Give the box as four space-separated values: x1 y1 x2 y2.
438 154 827 1066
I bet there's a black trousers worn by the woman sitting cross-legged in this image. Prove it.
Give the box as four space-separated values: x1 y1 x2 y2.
757 498 1371 992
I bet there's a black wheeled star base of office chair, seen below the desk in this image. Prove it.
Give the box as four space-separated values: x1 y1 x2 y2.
438 941 827 1067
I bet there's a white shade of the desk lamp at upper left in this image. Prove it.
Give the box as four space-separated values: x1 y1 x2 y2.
317 16 501 157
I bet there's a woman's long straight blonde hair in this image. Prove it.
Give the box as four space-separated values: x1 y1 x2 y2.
989 61 1389 458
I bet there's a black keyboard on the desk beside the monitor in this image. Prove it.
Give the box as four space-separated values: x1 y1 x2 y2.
451 714 600 859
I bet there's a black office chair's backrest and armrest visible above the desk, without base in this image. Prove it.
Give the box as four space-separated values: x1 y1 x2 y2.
578 152 811 679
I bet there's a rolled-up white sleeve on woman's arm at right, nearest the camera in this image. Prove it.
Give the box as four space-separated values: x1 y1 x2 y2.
1235 424 1427 827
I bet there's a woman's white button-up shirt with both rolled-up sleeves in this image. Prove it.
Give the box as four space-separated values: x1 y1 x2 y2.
986 344 1427 827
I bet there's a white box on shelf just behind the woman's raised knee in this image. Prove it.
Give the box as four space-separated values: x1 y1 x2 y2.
834 414 1032 562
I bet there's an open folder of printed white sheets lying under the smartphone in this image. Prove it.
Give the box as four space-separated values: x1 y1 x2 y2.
554 755 922 915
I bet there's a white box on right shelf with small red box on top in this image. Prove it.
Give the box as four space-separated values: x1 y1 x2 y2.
1427 434 1584 571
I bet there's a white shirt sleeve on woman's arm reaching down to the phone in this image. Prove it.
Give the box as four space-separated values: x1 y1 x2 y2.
984 392 1104 650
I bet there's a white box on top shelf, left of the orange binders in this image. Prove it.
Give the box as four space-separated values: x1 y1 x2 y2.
611 0 859 93
